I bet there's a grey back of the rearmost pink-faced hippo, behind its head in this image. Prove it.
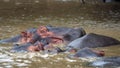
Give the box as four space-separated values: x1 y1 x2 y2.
47 27 86 42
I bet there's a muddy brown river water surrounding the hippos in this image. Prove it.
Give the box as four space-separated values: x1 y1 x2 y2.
0 0 120 68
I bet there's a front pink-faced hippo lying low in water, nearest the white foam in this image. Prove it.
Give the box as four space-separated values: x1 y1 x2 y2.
11 39 63 53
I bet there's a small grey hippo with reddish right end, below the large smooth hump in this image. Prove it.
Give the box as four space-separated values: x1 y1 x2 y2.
68 47 104 58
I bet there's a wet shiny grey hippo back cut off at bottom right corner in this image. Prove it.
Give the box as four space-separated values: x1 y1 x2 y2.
89 56 120 68
